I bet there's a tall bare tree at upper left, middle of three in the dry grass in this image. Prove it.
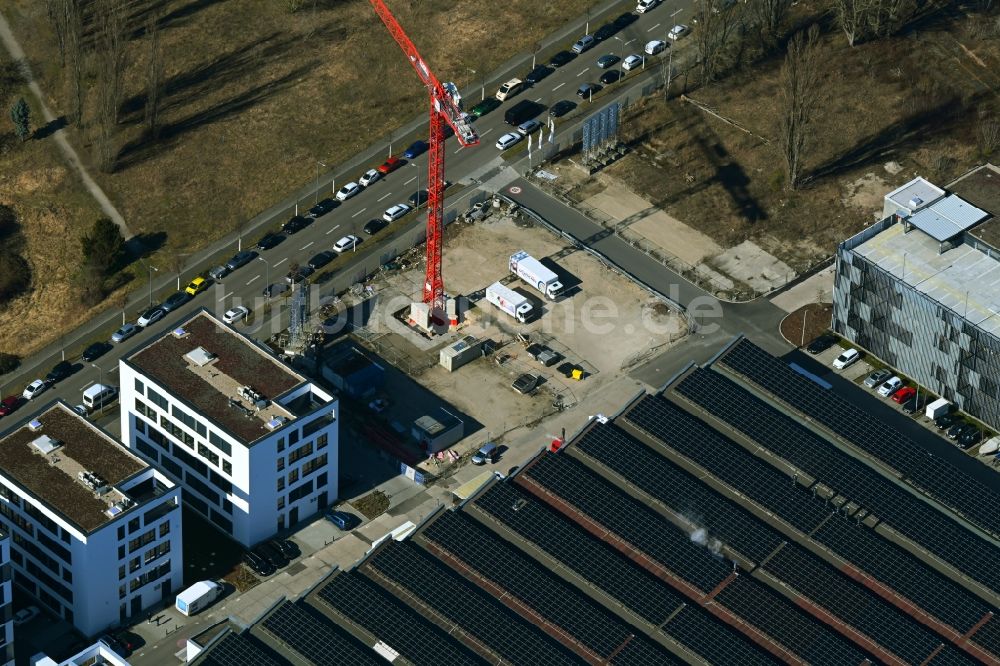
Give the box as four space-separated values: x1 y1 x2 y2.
96 0 127 172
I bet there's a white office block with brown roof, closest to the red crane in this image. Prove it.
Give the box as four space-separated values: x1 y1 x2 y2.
119 309 338 546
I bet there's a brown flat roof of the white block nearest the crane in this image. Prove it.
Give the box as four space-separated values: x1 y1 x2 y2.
131 310 306 444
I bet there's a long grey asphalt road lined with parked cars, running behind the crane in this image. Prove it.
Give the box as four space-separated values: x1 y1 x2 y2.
0 3 693 404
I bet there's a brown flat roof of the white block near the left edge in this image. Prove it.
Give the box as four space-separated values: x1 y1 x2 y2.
0 402 149 532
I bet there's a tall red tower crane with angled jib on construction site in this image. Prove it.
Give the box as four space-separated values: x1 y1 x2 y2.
369 0 479 312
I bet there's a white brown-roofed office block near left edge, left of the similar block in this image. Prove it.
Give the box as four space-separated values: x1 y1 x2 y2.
0 401 184 636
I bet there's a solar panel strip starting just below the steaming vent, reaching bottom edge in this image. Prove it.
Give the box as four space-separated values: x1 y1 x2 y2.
715 576 869 666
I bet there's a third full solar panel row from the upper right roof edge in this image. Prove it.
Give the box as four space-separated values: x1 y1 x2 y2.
620 392 990 632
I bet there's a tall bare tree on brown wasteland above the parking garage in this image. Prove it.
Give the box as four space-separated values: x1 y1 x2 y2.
778 24 820 190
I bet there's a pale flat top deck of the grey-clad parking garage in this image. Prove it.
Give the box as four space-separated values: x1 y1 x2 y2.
854 224 1000 336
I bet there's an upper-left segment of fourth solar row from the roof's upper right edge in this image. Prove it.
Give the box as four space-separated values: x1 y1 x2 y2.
575 418 784 562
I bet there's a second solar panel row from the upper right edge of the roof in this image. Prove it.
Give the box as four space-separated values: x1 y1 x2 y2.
673 369 1000 592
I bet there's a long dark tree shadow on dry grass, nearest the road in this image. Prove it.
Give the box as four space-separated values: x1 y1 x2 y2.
115 61 317 169
